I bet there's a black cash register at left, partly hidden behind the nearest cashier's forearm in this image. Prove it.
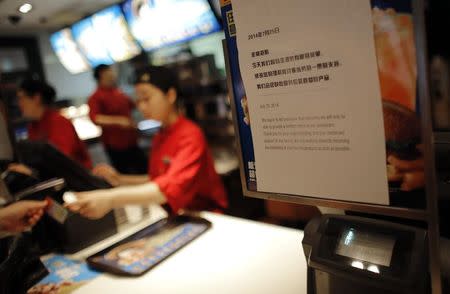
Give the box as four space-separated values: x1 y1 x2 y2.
16 141 117 253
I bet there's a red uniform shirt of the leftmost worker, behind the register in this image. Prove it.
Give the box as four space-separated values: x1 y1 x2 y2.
28 109 92 169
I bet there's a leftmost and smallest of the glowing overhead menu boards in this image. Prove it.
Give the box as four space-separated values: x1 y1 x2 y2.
50 29 90 74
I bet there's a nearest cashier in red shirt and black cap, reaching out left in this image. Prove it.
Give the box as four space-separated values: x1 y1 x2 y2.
68 67 228 218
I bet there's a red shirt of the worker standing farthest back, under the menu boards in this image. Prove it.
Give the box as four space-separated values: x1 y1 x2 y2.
88 88 137 151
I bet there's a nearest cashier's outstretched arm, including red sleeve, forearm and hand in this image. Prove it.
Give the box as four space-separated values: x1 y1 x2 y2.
72 133 206 219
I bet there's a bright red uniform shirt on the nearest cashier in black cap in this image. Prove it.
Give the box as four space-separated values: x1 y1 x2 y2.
149 117 228 212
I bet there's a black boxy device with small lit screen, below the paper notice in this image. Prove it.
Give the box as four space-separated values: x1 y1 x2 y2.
302 215 429 294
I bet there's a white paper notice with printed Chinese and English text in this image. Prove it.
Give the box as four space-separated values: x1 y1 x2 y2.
233 0 389 205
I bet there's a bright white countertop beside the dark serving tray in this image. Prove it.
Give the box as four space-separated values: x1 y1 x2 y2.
74 213 306 294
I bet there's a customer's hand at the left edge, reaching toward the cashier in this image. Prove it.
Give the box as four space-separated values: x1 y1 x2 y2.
0 201 48 233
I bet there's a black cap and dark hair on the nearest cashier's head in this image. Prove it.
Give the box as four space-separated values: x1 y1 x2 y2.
134 66 180 96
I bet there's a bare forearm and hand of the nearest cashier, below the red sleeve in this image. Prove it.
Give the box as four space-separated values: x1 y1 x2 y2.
66 182 167 219
